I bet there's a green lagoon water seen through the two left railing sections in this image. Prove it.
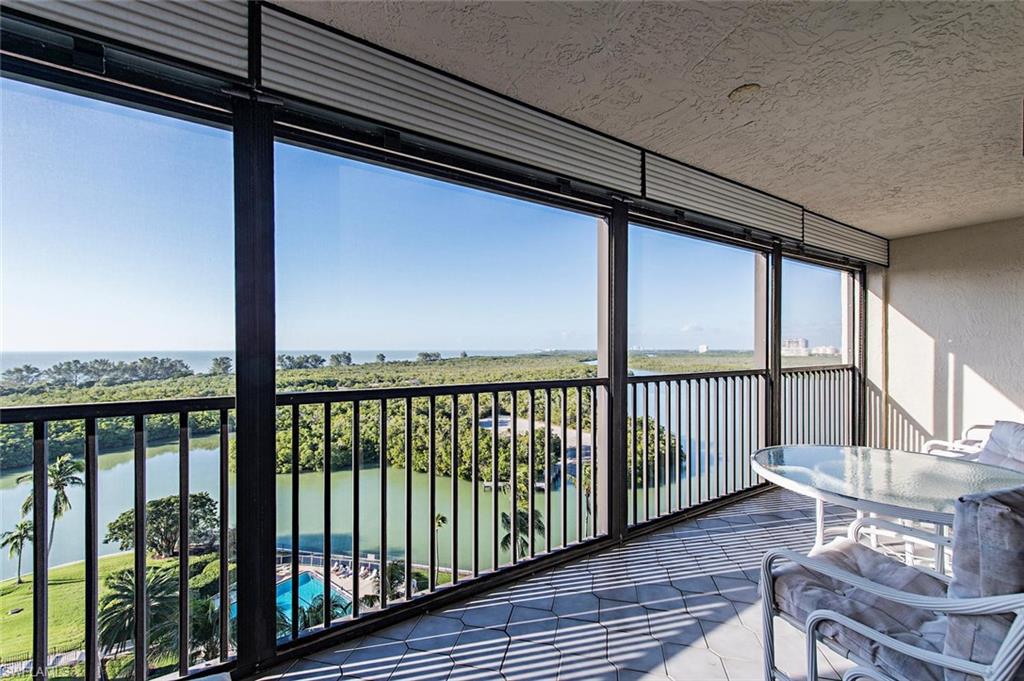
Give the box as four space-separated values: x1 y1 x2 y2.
0 436 588 579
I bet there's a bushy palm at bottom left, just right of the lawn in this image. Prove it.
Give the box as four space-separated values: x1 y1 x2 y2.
96 567 178 668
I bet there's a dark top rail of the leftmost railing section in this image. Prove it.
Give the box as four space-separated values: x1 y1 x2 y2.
0 395 234 425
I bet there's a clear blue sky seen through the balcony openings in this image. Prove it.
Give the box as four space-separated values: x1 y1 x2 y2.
0 79 840 352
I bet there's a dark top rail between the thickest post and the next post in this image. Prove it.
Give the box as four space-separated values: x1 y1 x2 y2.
278 378 608 407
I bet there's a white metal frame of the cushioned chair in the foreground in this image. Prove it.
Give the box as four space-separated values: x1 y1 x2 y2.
761 518 1024 681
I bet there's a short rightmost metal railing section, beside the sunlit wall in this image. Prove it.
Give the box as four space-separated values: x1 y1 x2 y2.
781 365 857 444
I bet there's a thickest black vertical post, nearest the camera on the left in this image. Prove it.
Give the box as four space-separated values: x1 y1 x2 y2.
232 96 276 676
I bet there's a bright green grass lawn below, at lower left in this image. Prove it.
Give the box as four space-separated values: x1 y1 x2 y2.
0 553 174 661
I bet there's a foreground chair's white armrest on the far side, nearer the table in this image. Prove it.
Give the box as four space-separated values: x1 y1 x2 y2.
761 549 1024 614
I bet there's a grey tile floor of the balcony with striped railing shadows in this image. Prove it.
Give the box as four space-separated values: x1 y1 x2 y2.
253 490 852 681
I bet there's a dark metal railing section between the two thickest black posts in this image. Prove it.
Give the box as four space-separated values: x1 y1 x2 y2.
278 379 606 640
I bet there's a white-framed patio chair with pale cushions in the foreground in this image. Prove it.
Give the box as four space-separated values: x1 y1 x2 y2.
761 487 1024 681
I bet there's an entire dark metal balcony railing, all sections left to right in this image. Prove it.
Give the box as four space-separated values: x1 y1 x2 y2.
0 366 855 681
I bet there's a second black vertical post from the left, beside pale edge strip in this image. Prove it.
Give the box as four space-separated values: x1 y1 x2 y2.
597 201 630 539
